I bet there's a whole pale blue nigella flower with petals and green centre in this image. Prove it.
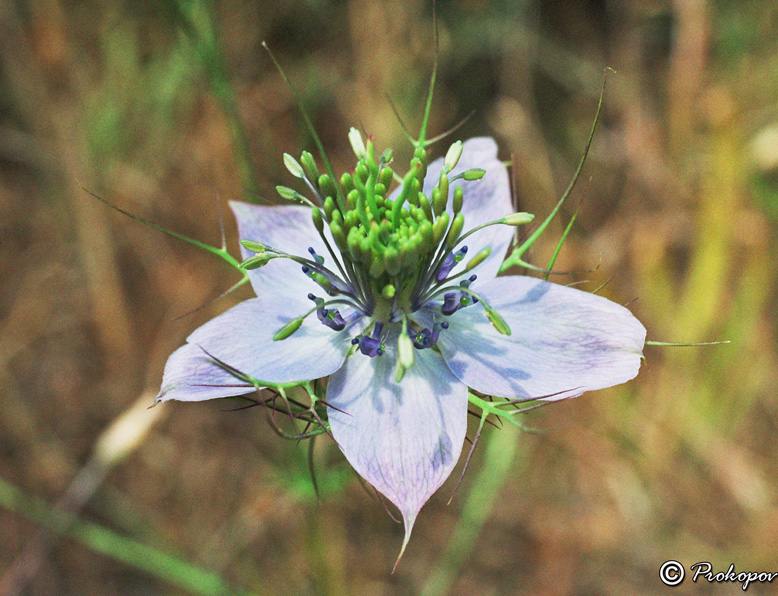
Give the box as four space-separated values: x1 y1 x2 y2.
158 129 645 548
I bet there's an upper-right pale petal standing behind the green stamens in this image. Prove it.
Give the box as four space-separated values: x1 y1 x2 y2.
392 137 516 280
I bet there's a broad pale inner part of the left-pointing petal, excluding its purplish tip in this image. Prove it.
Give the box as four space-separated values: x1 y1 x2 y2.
179 297 360 383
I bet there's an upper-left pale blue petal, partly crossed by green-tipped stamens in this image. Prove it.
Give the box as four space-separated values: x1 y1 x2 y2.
230 201 328 299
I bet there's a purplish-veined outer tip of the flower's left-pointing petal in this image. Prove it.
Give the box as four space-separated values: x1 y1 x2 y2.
155 344 255 401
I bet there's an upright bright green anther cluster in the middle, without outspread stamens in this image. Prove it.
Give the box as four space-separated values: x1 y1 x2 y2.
287 129 478 323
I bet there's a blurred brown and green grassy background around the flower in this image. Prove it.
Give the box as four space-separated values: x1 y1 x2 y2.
0 0 778 596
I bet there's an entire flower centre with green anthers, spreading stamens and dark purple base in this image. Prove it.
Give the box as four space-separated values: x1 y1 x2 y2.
236 128 531 374
